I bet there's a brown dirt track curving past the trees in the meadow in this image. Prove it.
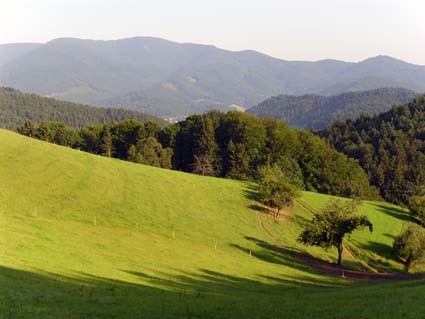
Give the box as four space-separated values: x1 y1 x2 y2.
255 211 422 281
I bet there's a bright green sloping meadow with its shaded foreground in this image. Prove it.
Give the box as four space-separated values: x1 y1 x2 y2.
0 130 425 319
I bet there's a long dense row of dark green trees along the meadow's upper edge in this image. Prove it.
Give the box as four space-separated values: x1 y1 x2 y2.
18 111 376 197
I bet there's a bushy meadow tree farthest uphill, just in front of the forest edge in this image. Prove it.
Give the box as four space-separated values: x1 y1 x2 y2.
258 164 300 221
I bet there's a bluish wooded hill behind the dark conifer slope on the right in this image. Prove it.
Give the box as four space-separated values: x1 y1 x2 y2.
247 88 417 129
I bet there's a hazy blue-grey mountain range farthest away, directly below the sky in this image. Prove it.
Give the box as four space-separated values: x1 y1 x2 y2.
0 37 425 116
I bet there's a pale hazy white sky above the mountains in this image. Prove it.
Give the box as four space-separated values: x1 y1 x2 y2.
0 0 425 65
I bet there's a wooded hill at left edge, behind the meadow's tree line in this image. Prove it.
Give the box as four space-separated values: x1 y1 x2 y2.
0 87 166 129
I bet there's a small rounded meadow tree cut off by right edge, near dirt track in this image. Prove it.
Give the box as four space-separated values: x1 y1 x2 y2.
393 225 425 272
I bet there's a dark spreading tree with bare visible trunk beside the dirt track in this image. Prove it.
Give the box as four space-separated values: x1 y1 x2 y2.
298 201 373 266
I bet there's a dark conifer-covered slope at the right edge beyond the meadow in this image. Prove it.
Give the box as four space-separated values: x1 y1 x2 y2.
320 97 425 203
